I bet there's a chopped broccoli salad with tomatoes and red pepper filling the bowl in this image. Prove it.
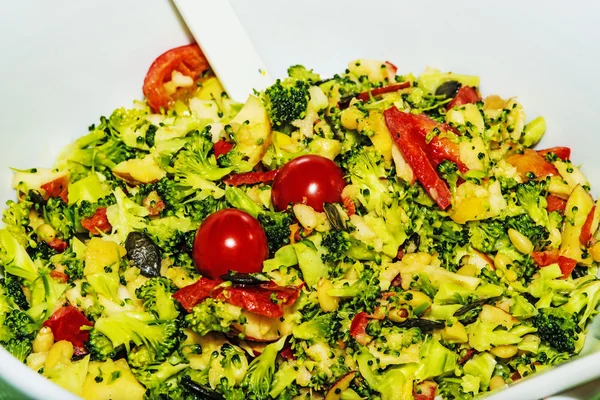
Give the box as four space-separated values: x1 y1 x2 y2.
0 44 600 400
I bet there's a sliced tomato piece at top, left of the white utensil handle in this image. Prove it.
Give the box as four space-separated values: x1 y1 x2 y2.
142 44 210 112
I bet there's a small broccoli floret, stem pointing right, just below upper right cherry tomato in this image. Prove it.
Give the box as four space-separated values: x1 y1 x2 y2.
321 230 381 265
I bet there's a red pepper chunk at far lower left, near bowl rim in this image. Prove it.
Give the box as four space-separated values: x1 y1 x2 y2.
43 305 93 355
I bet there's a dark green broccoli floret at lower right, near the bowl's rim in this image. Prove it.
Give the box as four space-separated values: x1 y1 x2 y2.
533 308 581 353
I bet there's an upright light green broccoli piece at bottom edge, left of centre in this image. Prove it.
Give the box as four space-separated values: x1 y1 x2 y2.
241 337 286 400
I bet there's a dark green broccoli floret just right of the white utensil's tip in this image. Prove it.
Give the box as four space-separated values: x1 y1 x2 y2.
262 78 310 128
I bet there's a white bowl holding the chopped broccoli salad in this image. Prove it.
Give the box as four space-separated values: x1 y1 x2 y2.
0 0 600 399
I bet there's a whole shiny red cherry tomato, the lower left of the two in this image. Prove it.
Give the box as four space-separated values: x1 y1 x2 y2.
192 209 269 279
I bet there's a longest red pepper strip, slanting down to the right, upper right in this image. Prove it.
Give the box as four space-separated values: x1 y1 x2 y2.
383 107 452 210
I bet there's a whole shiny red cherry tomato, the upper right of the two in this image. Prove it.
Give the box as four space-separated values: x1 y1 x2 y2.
271 155 346 212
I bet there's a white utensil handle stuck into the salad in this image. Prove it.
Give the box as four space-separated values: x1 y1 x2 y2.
173 0 273 103
